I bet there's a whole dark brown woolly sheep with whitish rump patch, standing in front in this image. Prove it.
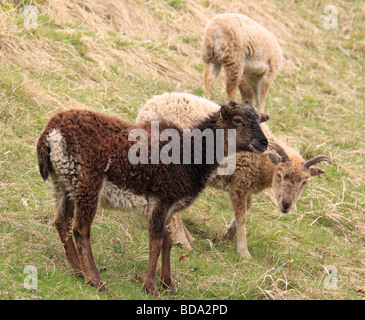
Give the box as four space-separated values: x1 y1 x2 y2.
37 102 267 293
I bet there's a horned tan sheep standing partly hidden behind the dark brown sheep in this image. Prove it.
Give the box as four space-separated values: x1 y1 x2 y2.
137 93 331 258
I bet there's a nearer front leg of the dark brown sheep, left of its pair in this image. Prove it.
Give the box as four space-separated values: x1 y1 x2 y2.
143 201 169 295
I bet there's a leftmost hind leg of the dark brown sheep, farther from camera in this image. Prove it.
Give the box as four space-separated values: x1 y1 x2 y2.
54 192 82 276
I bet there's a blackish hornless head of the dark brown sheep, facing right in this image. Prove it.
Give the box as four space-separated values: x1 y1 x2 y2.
221 101 269 153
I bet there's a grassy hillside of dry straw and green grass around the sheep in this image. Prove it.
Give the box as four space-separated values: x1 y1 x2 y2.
0 0 365 299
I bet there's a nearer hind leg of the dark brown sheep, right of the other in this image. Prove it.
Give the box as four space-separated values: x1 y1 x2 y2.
73 182 105 291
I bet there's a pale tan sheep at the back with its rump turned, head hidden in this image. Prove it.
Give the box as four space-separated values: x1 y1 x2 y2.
202 13 282 112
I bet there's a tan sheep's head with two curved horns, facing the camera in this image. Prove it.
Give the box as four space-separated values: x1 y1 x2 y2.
268 141 332 213
